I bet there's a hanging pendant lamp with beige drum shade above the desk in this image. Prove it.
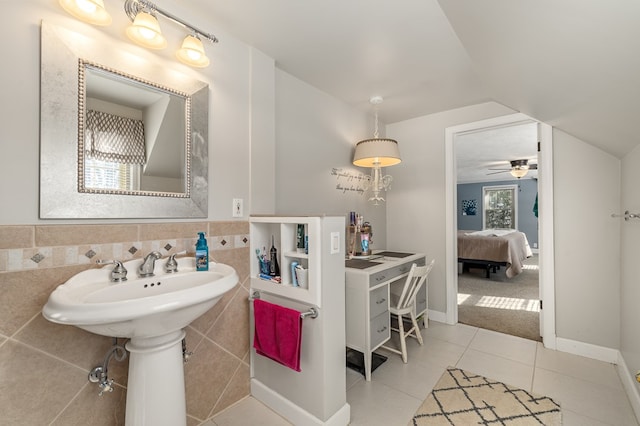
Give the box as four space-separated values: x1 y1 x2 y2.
353 96 402 205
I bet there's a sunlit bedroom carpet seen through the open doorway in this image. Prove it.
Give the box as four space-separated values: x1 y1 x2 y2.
458 254 542 341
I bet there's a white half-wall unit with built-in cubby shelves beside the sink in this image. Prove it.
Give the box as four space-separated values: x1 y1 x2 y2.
249 216 351 426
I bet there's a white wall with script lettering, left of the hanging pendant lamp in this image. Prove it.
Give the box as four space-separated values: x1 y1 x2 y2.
276 70 388 249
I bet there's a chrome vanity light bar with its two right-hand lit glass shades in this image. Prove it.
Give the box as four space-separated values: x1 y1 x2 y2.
124 0 218 68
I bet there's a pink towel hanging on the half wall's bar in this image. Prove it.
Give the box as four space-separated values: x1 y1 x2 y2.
253 299 302 371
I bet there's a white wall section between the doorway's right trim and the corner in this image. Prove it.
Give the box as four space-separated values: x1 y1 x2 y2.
553 129 620 349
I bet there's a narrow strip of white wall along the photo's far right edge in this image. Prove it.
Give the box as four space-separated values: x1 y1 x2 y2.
620 143 640 392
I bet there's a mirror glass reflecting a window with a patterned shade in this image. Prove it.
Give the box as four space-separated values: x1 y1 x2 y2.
78 63 191 197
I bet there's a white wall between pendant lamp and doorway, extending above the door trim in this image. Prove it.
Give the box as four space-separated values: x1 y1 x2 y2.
387 102 514 317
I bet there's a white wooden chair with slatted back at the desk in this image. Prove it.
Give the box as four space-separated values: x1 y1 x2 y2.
382 259 435 364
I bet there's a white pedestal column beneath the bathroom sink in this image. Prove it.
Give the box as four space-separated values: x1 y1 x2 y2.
125 330 187 426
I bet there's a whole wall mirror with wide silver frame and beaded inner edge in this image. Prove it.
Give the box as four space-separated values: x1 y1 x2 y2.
40 22 209 219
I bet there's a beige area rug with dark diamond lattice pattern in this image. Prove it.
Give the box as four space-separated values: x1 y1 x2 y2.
409 367 562 426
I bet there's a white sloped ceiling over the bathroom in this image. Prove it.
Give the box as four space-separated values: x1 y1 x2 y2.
182 0 640 158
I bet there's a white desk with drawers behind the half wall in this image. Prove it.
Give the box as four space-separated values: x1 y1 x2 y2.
345 251 427 381
